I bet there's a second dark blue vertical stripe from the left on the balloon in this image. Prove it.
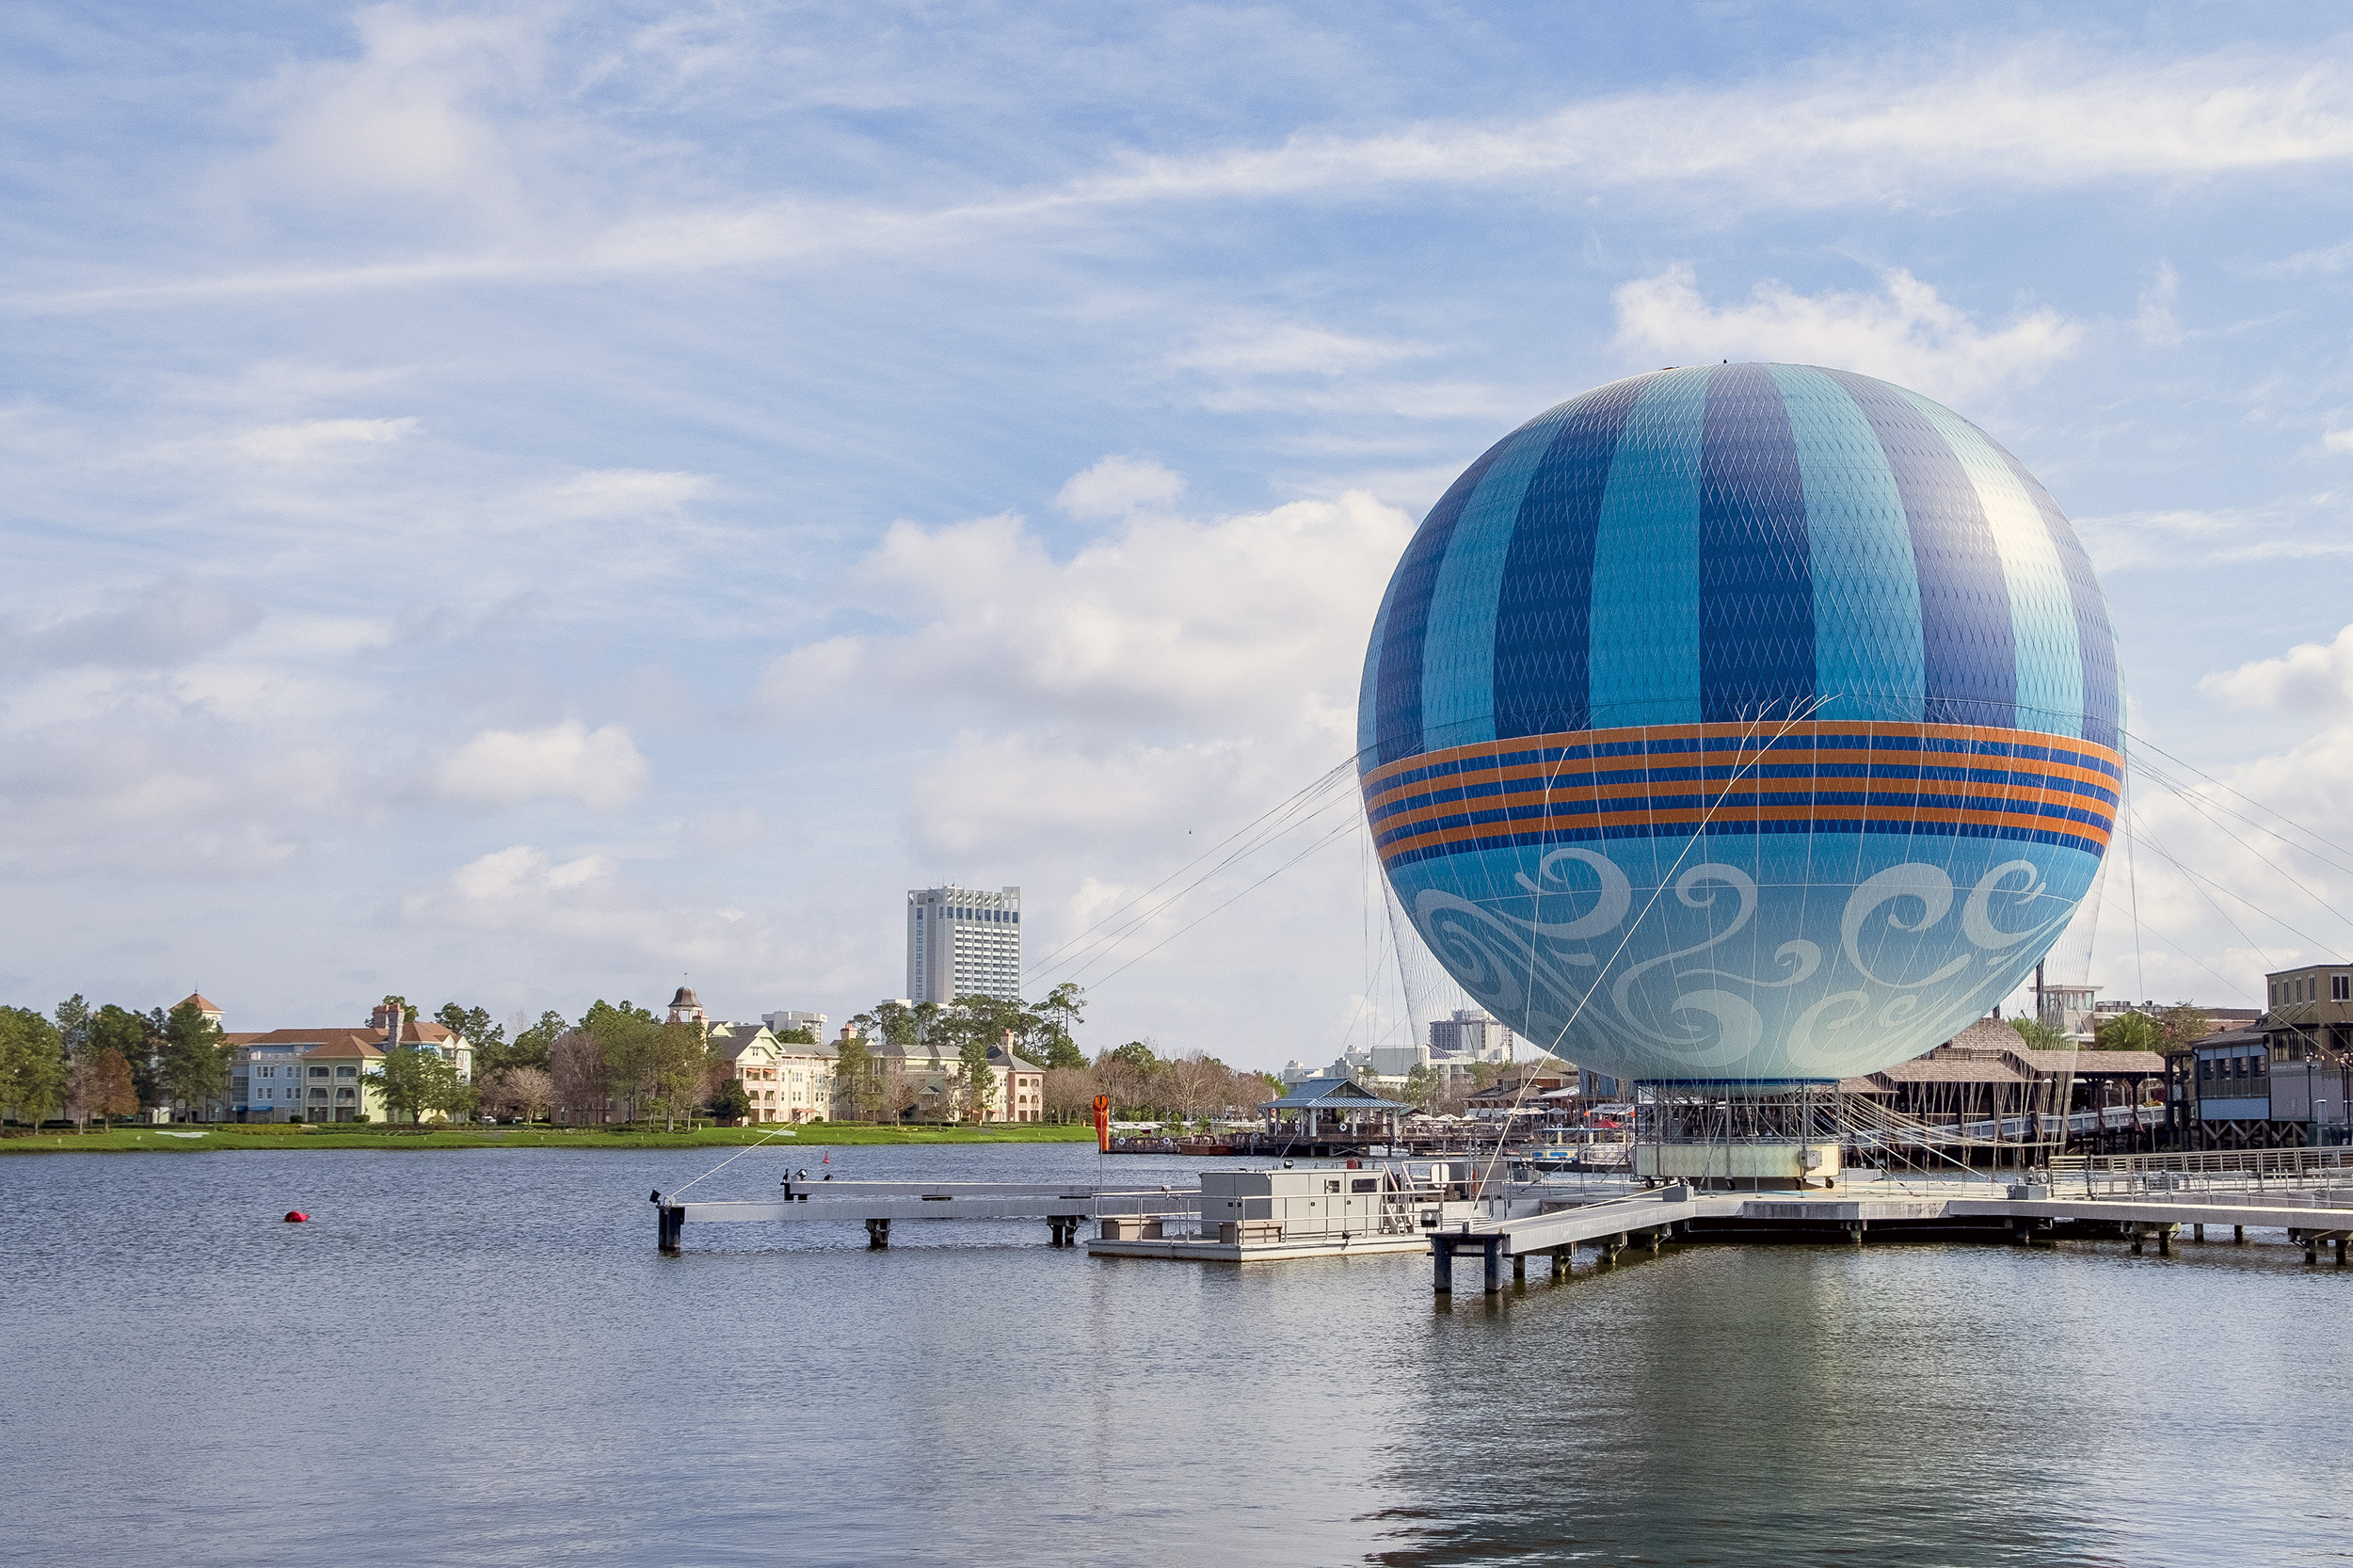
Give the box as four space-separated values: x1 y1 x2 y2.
1492 376 1650 737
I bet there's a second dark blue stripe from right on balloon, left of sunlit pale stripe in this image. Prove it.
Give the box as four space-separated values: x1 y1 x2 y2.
1824 370 2019 725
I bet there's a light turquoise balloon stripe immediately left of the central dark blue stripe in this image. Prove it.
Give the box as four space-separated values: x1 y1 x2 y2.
1586 370 1708 725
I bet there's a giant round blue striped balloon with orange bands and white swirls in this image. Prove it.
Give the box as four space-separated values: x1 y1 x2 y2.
1358 365 2125 1085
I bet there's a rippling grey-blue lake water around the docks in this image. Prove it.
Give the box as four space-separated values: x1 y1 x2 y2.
0 1146 2353 1565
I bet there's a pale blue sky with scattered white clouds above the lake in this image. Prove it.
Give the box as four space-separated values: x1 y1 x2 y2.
0 0 2353 1066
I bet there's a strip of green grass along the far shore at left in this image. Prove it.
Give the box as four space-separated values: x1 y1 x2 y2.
0 1121 1095 1154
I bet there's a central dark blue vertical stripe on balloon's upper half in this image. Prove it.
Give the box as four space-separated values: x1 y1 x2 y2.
1697 365 1815 723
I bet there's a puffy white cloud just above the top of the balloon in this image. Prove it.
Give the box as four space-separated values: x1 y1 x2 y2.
1612 266 2083 403
